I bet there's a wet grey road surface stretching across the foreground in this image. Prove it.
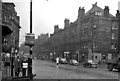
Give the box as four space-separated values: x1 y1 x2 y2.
33 60 119 79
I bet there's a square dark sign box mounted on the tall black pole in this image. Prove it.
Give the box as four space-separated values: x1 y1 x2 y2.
25 33 35 46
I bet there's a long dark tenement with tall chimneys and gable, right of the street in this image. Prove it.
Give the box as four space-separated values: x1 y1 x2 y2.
40 3 118 62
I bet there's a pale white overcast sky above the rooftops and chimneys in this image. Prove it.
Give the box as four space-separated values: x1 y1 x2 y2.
2 0 120 44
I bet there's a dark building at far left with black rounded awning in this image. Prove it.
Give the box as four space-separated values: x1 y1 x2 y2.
0 2 21 69
